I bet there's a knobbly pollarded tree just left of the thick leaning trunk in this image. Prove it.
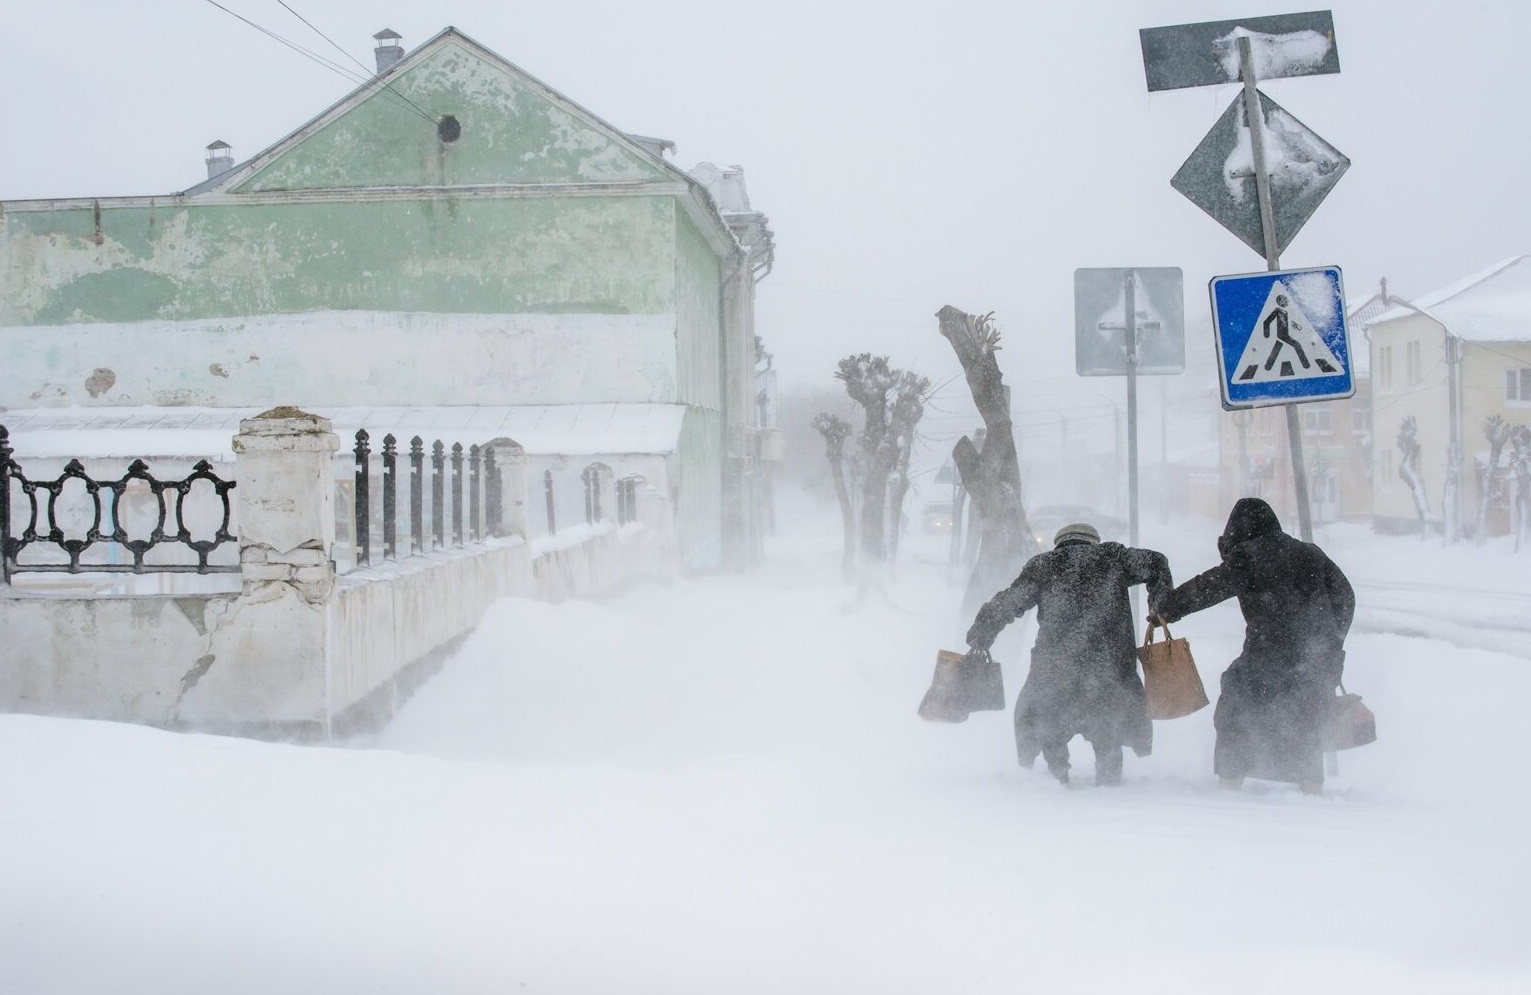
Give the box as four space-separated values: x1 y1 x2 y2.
834 352 931 586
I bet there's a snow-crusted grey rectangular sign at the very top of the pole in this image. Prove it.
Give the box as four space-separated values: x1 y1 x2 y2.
1138 11 1340 92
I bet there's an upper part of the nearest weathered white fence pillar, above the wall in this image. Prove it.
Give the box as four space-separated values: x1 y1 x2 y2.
234 407 340 605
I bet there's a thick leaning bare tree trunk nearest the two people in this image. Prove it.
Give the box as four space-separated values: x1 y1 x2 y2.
935 305 1036 614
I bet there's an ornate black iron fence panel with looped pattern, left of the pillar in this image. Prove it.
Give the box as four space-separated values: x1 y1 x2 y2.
0 426 239 582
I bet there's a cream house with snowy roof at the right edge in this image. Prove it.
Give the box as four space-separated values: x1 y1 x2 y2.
1367 256 1531 534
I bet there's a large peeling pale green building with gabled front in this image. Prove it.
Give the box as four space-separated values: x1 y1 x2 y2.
0 28 773 569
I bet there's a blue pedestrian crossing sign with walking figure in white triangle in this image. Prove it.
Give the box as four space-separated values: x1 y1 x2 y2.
1208 266 1355 410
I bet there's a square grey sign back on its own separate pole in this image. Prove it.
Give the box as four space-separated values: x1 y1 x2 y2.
1073 266 1185 377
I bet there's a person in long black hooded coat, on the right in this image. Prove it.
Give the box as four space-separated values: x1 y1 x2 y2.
1157 498 1355 793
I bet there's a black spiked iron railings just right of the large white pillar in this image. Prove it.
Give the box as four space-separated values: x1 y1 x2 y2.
352 429 504 566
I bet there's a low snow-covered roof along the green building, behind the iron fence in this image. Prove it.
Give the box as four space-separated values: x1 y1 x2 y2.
0 404 686 461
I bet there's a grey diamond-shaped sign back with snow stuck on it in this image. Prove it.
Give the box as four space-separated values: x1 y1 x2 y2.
1170 93 1350 257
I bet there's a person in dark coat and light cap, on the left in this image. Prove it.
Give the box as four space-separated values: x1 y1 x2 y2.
968 524 1174 784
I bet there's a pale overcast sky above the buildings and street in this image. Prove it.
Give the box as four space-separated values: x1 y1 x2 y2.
0 0 1531 468
